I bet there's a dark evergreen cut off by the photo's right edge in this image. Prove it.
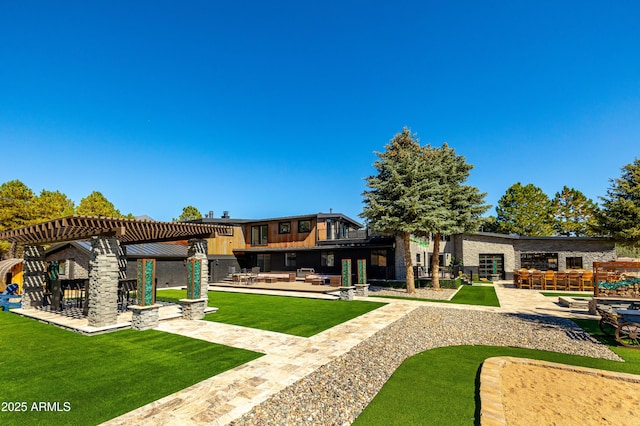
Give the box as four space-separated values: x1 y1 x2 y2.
594 158 640 247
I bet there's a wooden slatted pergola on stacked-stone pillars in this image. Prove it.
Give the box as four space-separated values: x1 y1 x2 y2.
0 215 228 329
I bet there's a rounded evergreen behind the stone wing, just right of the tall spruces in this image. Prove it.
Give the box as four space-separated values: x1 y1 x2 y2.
496 182 554 237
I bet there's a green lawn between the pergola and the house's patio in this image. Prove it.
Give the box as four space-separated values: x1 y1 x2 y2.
157 290 384 337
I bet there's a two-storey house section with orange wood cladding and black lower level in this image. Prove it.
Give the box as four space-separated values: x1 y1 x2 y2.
194 212 395 281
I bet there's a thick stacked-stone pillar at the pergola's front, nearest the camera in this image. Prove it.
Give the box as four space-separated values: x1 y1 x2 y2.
87 236 119 327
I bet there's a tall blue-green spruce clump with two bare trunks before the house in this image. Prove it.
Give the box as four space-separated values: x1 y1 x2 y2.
360 128 488 293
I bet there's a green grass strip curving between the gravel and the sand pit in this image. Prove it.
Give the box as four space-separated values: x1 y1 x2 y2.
354 342 640 426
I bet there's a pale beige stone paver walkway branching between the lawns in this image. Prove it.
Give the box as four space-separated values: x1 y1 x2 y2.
105 284 596 426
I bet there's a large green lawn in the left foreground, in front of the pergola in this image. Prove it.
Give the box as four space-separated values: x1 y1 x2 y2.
0 312 262 425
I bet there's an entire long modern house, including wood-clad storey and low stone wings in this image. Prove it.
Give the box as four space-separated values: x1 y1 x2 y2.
37 212 616 288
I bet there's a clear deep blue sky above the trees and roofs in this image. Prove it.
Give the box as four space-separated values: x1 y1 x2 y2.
0 0 640 220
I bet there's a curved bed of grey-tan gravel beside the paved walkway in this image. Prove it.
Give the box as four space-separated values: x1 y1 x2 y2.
231 306 621 425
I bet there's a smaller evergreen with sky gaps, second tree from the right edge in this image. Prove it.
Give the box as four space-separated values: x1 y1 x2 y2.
553 185 597 237
